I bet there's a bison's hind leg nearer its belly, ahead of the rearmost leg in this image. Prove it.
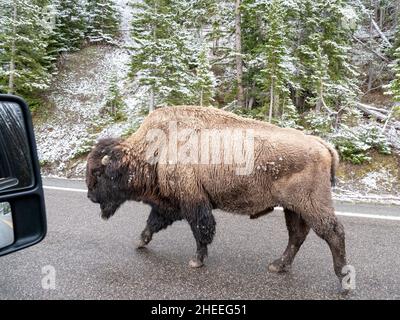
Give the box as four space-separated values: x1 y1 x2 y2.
268 209 310 272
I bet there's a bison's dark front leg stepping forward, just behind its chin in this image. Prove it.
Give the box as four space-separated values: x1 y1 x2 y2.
137 208 180 249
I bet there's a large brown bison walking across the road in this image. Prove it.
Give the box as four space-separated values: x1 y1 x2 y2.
86 106 346 279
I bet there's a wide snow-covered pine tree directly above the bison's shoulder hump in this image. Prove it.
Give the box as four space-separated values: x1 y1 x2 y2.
130 0 199 112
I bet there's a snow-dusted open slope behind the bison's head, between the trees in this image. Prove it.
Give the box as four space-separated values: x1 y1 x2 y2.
35 0 142 177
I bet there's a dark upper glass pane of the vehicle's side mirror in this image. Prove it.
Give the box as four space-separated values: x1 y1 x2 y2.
0 102 34 193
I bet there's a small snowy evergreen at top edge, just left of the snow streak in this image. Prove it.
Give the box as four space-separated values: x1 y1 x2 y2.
86 0 120 43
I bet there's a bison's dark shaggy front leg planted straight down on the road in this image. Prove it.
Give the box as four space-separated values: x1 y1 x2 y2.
183 204 215 268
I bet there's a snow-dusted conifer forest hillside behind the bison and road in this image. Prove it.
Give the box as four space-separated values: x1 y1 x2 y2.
0 0 400 199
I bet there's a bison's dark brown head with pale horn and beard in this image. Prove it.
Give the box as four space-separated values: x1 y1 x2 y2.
86 139 128 219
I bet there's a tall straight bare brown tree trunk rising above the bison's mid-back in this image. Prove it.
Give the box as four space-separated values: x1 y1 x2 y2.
235 0 244 108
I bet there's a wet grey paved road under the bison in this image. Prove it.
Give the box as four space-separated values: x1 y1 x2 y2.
0 179 400 299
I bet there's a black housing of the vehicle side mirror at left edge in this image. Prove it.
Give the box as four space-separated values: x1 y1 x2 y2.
0 94 47 256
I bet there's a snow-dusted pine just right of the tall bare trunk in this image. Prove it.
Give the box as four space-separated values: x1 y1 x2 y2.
242 0 297 111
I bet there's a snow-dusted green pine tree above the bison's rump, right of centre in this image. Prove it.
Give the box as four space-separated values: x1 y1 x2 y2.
294 0 358 110
